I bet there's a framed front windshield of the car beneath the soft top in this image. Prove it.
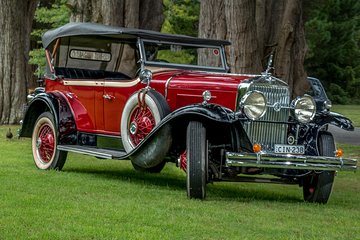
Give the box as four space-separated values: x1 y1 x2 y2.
143 40 227 72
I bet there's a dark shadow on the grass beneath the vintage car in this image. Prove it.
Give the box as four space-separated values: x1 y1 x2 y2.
65 168 303 203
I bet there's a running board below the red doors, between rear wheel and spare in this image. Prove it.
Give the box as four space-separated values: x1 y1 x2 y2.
57 145 128 160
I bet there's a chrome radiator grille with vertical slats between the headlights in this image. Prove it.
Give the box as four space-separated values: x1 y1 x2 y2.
244 83 290 151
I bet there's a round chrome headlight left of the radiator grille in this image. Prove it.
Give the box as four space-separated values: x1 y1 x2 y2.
240 91 266 120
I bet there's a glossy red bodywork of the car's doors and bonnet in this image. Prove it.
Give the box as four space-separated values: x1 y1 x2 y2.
46 70 250 137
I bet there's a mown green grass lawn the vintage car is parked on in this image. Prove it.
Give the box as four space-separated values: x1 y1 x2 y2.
0 126 360 240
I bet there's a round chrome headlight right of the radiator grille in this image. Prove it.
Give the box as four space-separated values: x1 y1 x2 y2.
293 95 316 123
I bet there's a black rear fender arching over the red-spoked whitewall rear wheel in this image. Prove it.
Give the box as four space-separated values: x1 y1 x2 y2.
19 92 76 144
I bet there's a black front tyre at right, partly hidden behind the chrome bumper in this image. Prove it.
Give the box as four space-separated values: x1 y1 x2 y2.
303 132 336 204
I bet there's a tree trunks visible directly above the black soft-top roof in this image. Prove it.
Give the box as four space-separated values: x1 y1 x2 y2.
68 0 164 31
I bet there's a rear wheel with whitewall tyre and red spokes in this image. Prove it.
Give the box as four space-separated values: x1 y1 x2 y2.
32 112 67 170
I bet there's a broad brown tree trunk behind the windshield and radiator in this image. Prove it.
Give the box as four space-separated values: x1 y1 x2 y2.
199 0 307 95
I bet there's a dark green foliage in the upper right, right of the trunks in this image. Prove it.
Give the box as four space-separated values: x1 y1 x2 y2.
305 0 360 103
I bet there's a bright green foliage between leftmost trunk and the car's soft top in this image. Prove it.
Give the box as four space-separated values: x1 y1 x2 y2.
29 0 70 76
